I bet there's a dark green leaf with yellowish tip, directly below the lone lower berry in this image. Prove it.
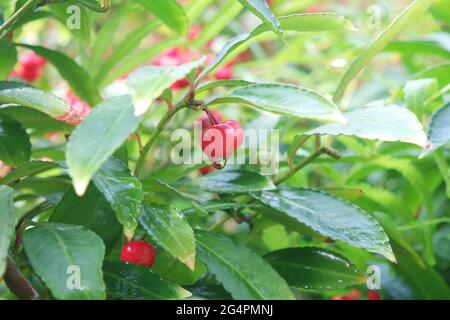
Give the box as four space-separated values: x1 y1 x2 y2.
103 261 191 300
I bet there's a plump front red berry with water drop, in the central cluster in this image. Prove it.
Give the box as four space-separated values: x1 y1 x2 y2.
202 120 244 164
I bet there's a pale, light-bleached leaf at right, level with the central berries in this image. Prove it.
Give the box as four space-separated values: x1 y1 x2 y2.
305 104 427 147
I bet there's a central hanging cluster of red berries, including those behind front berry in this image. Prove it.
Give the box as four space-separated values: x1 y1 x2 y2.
198 109 244 174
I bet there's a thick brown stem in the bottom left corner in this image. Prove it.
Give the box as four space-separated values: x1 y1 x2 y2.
5 256 39 300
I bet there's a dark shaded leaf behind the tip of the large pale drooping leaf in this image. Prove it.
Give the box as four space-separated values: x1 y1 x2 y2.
50 185 122 251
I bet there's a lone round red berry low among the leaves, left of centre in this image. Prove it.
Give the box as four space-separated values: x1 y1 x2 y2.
120 240 155 268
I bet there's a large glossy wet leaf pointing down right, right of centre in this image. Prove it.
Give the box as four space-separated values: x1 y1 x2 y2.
254 188 395 261
